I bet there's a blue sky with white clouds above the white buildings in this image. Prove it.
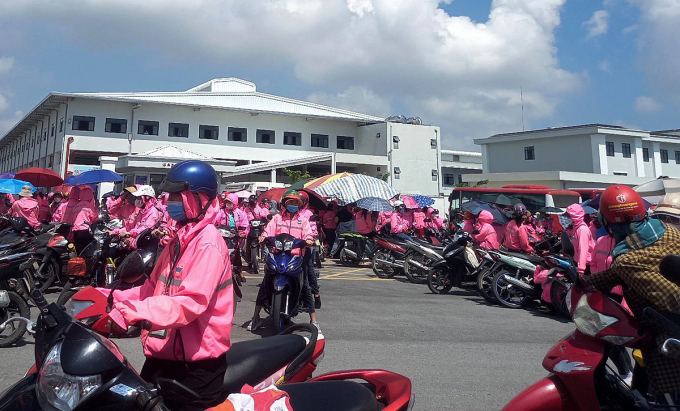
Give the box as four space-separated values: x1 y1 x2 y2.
0 0 680 151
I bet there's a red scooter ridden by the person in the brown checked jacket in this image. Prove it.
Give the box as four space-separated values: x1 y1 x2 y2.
503 234 652 411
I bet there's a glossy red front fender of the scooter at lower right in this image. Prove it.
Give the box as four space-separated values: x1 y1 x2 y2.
503 375 578 411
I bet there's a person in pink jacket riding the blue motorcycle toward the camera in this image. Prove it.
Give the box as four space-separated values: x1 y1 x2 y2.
247 190 319 331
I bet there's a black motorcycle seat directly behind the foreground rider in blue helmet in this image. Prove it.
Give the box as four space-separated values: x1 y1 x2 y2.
222 334 307 398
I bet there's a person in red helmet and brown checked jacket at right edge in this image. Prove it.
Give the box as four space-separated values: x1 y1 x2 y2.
585 185 680 404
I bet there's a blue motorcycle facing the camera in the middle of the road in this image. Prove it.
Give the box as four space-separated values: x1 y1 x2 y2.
264 234 306 332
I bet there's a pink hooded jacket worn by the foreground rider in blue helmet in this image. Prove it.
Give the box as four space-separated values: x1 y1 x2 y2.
110 191 234 362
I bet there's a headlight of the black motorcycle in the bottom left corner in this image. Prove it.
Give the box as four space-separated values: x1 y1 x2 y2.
37 342 102 411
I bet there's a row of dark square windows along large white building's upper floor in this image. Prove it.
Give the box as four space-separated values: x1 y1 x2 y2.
73 116 354 150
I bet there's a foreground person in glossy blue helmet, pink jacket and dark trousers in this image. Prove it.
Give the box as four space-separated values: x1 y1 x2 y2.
109 160 234 410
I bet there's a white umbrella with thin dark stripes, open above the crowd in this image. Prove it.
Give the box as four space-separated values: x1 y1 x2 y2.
313 174 397 204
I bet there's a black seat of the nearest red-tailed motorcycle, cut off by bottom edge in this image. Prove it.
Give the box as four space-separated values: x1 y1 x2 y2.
277 381 378 411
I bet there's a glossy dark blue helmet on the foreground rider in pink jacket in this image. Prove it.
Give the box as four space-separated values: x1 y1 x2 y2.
158 160 218 200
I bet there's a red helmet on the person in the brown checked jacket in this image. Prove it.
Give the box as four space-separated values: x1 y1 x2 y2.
600 185 647 224
